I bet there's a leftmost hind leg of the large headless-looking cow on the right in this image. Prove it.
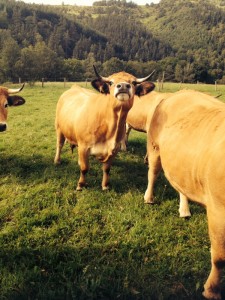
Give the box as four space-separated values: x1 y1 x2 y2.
144 146 162 204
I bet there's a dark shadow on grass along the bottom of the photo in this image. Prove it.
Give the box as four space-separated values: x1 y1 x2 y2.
0 242 215 300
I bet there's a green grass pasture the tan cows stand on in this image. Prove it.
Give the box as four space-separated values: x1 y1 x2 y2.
0 83 225 300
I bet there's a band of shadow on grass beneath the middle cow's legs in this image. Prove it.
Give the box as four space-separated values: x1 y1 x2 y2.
0 140 177 203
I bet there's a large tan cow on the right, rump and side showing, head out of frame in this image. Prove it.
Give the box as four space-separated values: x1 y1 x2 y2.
144 90 225 300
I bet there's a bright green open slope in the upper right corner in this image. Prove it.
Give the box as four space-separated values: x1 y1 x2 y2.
143 0 225 54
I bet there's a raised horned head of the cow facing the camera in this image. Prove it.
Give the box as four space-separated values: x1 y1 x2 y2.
91 66 155 101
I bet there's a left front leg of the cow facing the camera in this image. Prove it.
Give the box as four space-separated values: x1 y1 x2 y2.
77 146 89 191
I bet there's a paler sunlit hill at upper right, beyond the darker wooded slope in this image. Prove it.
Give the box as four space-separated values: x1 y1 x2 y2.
62 0 225 82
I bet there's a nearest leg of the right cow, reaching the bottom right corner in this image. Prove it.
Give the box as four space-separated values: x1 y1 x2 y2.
203 207 225 300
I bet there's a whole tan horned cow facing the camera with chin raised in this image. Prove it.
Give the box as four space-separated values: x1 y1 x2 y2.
54 67 155 190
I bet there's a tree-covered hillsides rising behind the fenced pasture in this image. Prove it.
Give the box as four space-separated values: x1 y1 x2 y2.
0 0 225 83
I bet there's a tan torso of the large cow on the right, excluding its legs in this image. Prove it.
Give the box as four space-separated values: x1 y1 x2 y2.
150 91 225 205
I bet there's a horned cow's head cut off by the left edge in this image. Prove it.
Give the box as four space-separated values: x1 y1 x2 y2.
0 84 25 132
